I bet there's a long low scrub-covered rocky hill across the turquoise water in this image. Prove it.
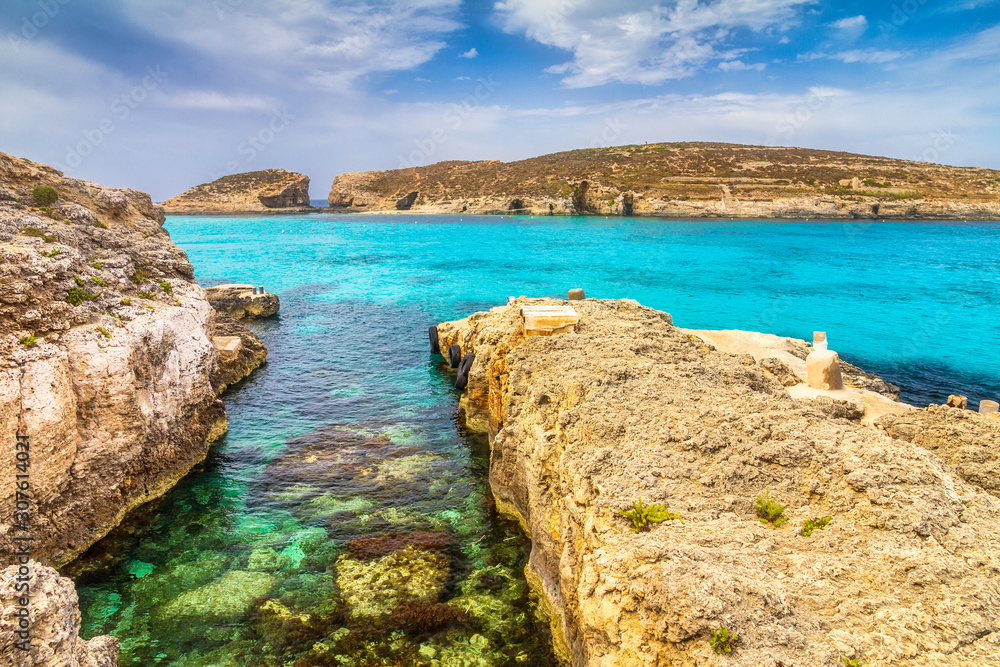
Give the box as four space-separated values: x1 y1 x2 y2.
329 143 1000 219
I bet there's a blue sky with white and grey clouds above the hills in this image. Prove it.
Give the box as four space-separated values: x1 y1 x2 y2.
0 0 1000 201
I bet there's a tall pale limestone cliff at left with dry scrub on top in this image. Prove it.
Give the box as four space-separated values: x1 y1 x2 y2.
0 153 226 567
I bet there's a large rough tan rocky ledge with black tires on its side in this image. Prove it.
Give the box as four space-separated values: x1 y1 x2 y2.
437 299 1000 667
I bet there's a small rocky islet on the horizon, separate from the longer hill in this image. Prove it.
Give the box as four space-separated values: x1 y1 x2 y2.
163 169 310 215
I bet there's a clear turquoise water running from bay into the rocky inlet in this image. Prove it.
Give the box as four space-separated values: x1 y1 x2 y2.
71 215 1000 666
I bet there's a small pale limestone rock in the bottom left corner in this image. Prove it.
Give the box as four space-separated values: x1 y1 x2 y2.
0 561 118 667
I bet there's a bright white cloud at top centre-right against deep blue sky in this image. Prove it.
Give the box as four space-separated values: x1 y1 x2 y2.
494 0 812 88
